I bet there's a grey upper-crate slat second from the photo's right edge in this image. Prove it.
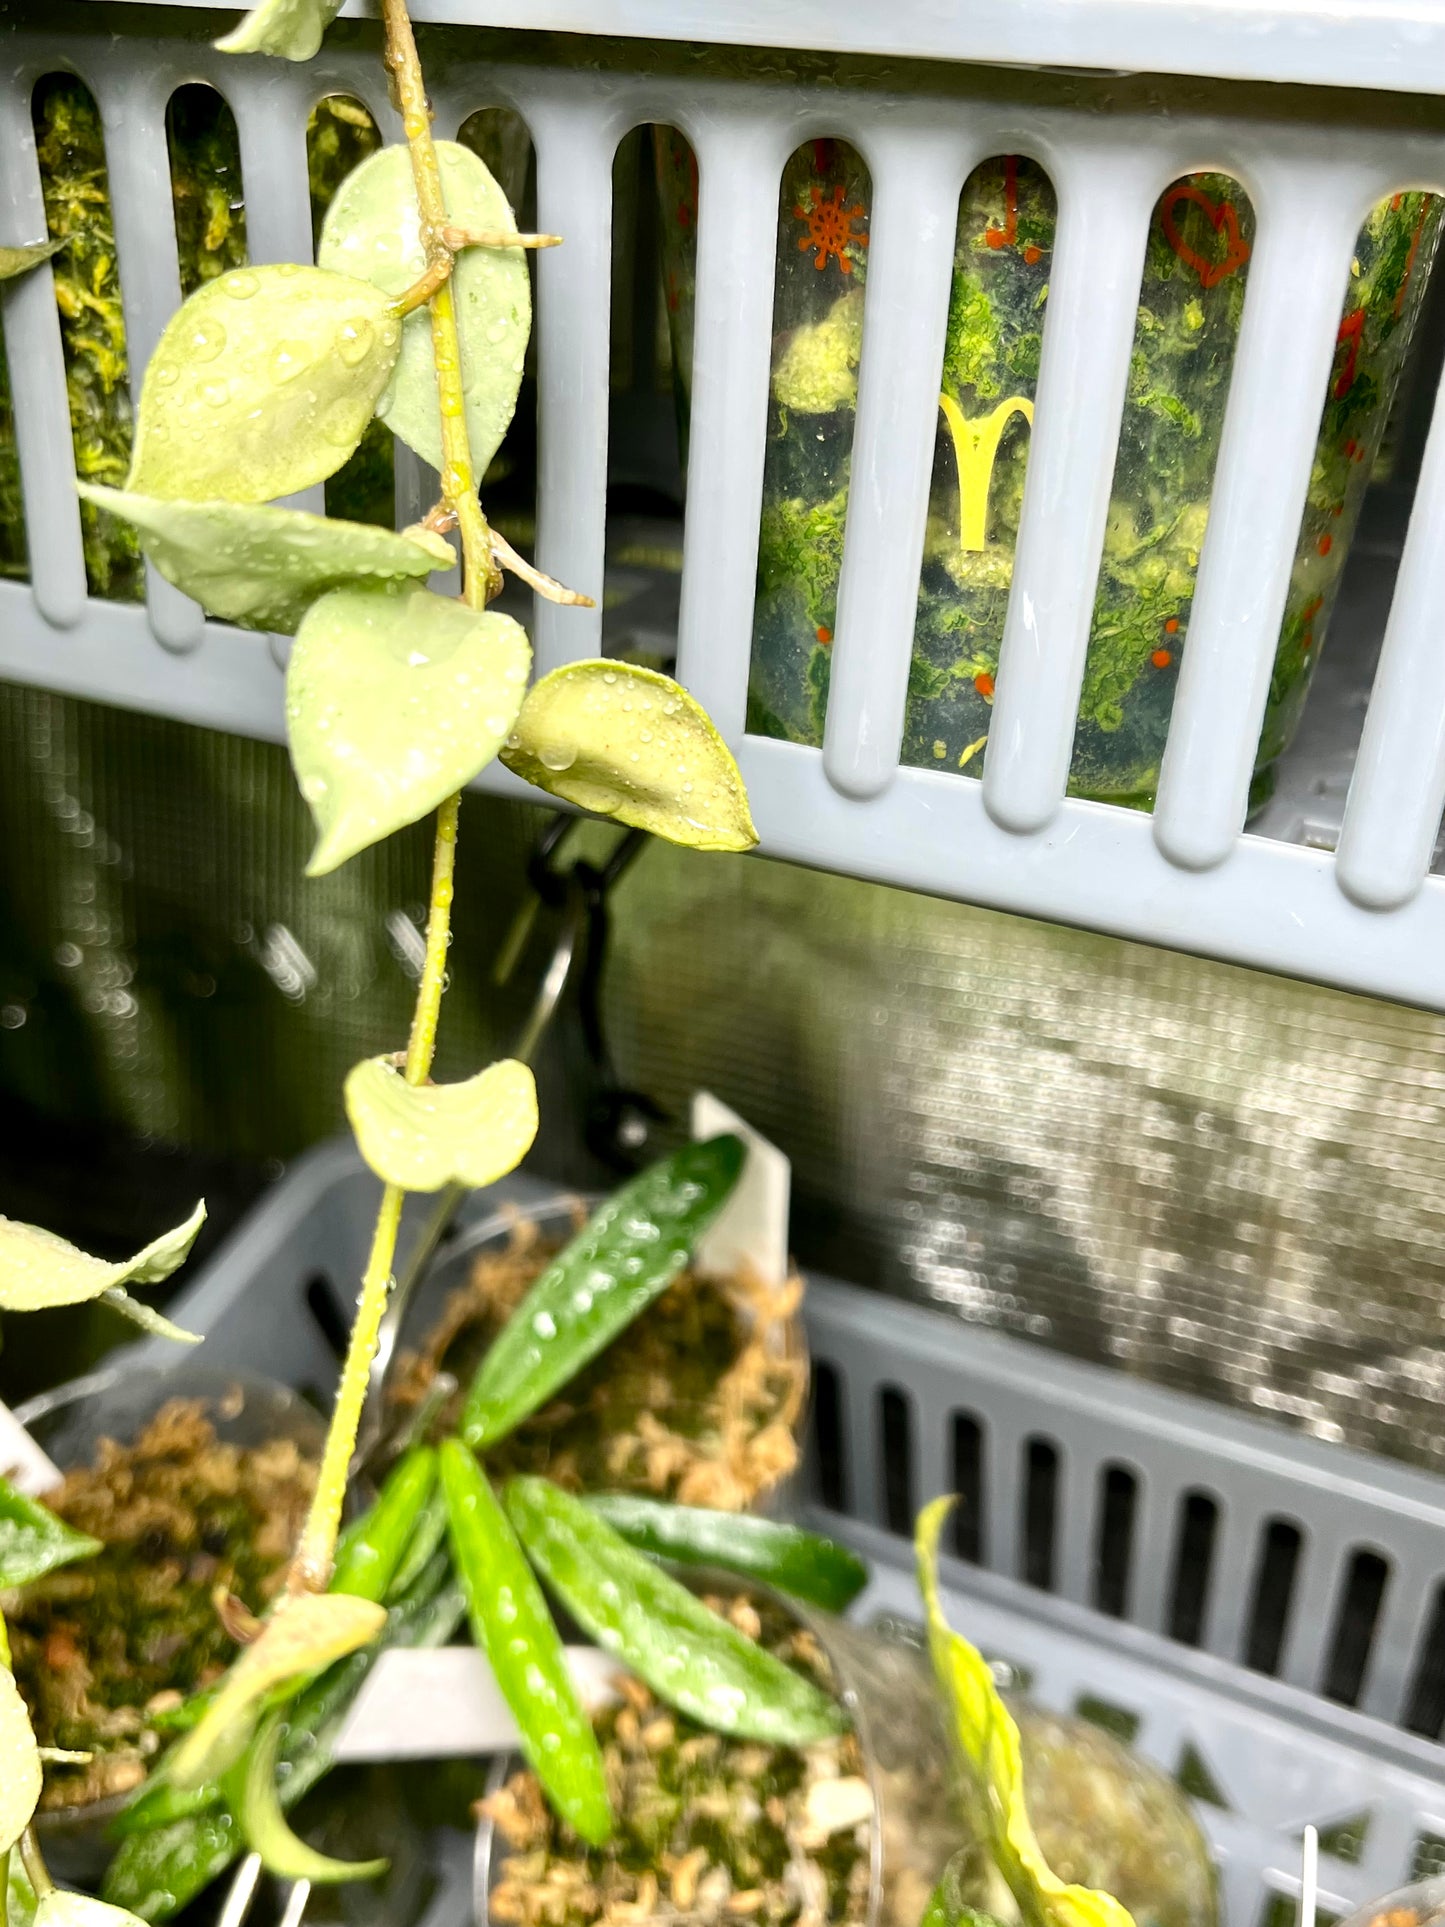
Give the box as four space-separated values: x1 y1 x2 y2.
1154 158 1374 869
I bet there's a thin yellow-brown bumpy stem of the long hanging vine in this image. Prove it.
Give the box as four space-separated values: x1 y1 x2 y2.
287 0 501 1592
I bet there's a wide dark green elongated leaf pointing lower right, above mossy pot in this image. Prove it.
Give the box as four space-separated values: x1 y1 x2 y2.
503 1478 848 1746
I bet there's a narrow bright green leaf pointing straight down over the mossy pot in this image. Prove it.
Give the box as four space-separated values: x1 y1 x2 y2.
441 1439 613 1846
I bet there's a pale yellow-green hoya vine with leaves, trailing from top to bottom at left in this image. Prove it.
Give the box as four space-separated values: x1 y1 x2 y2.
0 0 757 1919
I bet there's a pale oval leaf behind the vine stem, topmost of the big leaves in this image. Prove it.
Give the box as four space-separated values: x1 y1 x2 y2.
316 141 532 476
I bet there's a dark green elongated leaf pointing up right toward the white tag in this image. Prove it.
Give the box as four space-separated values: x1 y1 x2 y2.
460 1133 746 1451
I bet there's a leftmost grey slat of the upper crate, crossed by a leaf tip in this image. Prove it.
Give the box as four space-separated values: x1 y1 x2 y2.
0 69 87 642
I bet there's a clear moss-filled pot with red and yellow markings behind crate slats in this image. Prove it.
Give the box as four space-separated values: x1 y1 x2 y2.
657 131 1441 805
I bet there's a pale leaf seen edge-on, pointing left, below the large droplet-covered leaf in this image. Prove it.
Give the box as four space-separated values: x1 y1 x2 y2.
77 482 457 636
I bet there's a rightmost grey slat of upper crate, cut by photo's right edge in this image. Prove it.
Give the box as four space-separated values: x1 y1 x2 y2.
1335 348 1445 910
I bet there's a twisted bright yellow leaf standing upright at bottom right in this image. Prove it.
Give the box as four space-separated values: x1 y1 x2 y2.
915 1499 1133 1927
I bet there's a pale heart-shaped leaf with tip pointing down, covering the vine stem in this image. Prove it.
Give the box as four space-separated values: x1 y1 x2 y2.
285 574 532 877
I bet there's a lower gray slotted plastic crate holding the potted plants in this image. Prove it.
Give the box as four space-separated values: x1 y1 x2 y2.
93 1145 1445 1927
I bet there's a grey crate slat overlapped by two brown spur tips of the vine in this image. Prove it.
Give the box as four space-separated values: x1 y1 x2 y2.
532 96 620 674
